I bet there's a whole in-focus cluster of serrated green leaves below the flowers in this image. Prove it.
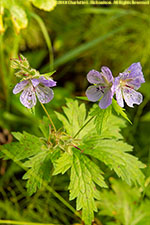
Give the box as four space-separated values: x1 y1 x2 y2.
1 99 144 225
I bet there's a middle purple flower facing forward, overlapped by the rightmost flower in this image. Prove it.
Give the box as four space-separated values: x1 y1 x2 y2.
86 66 114 109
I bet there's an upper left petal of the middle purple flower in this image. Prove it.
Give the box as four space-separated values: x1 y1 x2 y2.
87 70 104 84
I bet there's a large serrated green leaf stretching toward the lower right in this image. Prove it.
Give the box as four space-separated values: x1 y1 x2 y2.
79 136 145 186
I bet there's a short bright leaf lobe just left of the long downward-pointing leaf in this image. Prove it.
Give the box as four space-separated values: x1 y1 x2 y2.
53 152 72 175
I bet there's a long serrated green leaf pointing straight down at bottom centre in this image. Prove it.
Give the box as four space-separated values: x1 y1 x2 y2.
69 150 107 225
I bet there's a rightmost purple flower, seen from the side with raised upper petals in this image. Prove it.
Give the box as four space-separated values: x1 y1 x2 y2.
114 62 145 107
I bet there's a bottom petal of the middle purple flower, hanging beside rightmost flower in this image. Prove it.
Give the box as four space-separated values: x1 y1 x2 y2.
99 89 113 109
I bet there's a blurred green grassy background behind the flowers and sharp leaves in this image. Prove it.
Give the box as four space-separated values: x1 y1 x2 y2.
0 2 150 225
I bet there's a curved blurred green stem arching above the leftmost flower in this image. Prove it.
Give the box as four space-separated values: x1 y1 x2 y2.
30 13 54 71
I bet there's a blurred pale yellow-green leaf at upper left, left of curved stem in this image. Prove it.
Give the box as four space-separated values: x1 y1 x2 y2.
10 5 28 33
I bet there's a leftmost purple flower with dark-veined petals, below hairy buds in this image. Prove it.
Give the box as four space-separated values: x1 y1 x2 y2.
13 76 56 108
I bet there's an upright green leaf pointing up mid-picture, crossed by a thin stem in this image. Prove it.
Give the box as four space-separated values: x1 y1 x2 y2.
55 99 94 138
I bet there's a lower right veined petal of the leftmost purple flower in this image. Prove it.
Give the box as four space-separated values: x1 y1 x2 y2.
35 84 54 103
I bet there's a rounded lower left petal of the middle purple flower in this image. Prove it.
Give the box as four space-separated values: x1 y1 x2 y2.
85 85 104 102
